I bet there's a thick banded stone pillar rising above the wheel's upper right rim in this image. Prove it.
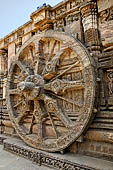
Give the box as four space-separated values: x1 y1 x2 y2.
80 0 101 62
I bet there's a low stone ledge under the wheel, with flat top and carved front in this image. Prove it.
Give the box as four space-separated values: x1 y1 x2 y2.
0 135 113 170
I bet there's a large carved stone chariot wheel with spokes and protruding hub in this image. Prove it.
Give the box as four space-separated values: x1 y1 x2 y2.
7 31 95 152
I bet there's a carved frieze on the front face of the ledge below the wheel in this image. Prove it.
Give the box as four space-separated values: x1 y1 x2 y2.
4 142 97 170
